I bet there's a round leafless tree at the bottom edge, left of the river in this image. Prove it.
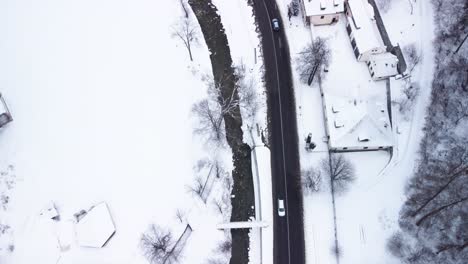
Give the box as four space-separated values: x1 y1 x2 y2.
140 224 177 264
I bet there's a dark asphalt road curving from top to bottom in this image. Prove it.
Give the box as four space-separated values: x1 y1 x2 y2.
253 0 305 264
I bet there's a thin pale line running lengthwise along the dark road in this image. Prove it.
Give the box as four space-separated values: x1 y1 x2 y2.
262 0 291 264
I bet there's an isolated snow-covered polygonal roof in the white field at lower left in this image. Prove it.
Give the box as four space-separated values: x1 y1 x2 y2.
76 202 115 248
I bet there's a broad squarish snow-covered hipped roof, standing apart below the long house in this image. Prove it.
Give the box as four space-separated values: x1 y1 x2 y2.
324 94 392 149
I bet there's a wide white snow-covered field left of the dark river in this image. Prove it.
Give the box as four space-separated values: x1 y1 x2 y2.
0 0 233 264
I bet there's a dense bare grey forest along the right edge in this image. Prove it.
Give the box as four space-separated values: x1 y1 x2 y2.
388 0 468 264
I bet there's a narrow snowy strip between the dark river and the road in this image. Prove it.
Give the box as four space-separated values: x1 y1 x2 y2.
213 0 273 263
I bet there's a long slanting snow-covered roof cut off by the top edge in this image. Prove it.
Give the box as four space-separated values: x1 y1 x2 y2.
348 0 384 53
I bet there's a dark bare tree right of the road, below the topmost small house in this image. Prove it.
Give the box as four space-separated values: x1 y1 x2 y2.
297 37 331 85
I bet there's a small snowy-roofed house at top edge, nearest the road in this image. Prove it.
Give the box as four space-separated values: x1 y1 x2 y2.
301 0 344 25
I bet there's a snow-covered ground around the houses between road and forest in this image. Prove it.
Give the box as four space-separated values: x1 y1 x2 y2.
277 0 433 264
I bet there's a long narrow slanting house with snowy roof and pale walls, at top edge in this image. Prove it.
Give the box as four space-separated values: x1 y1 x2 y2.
345 0 387 61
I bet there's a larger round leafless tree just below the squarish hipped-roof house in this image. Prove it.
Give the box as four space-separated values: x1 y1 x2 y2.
322 153 355 192
